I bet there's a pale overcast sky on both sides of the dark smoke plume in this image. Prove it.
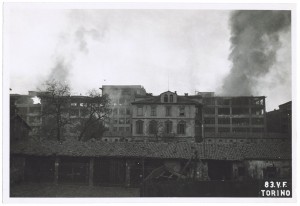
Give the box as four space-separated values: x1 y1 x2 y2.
4 8 291 110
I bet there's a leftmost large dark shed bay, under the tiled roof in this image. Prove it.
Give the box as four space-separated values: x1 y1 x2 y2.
24 156 54 182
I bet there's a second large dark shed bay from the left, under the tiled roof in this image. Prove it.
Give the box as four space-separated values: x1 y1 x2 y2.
58 157 89 184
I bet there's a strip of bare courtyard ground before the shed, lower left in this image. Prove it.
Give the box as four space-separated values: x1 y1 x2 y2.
10 183 140 197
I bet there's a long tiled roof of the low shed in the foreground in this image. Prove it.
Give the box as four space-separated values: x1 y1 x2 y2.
11 138 291 160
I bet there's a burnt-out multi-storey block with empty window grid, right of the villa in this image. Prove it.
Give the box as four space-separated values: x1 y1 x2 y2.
188 92 266 141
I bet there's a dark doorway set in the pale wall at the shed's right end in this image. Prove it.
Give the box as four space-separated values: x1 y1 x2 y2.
208 160 232 180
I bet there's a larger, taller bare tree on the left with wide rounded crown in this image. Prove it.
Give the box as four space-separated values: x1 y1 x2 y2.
38 80 71 141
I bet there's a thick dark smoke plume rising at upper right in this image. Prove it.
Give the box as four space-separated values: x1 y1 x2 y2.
222 10 291 96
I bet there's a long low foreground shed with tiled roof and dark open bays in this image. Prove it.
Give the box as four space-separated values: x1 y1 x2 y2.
10 140 291 186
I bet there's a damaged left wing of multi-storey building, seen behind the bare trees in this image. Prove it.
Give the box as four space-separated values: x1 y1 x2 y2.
10 91 109 138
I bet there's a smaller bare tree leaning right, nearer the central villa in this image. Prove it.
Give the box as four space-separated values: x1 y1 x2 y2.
78 89 111 140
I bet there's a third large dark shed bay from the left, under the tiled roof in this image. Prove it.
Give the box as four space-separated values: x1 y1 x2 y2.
94 158 125 185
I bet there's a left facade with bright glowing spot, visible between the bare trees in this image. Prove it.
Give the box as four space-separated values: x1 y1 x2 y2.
10 91 105 138
